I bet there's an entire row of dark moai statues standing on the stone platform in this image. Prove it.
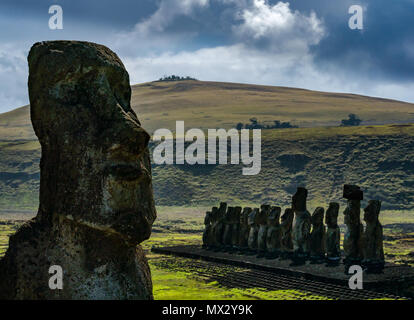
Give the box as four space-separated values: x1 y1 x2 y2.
203 185 384 273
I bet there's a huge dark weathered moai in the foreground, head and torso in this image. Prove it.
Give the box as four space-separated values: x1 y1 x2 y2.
0 41 156 299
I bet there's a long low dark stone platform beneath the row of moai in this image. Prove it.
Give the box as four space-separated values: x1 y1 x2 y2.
152 245 414 298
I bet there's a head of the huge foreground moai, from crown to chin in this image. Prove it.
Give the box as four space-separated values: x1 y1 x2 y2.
28 41 156 244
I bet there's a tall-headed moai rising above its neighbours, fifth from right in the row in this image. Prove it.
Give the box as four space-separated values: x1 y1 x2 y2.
292 187 312 264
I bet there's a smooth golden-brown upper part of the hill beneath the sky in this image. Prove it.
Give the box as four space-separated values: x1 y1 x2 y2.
0 81 414 141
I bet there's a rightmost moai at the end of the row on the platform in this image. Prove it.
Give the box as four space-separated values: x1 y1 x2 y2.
362 200 385 273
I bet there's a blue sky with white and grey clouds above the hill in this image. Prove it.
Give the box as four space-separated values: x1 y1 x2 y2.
0 0 414 112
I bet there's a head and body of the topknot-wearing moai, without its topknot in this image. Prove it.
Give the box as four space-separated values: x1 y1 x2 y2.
343 187 364 265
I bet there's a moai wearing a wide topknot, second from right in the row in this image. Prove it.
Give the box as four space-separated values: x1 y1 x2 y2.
343 185 364 273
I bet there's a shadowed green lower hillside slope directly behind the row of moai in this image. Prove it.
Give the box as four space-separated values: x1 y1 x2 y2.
0 125 414 210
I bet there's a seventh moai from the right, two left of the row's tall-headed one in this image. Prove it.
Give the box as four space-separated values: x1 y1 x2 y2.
266 207 282 259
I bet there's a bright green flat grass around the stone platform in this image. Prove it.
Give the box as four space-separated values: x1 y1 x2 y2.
0 206 414 300
